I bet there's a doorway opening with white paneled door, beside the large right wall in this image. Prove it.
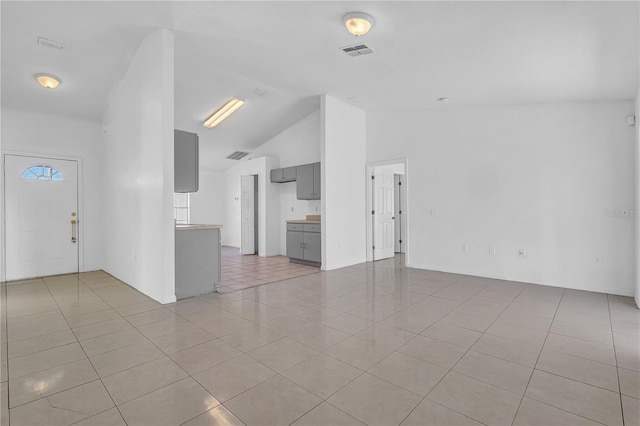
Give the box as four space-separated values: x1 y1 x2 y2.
366 159 409 265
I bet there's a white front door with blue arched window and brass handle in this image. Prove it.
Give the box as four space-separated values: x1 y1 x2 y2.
4 155 79 281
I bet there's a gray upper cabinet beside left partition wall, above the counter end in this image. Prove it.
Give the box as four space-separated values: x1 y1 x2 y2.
173 129 199 192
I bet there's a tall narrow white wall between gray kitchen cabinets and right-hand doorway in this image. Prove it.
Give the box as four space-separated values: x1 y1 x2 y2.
320 95 367 270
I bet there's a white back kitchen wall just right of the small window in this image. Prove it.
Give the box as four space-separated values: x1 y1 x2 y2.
190 170 227 226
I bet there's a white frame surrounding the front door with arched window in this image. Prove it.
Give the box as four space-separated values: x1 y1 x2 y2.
0 149 85 281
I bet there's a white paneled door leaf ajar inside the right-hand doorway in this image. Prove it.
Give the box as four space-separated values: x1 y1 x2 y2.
373 170 395 260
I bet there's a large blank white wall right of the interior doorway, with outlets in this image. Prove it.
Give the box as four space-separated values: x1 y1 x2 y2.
367 102 635 295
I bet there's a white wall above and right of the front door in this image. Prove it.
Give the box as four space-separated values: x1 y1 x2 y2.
1 107 105 271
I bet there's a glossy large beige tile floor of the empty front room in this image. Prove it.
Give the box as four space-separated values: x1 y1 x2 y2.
0 260 640 426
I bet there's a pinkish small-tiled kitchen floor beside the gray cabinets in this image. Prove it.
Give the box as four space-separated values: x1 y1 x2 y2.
218 246 320 293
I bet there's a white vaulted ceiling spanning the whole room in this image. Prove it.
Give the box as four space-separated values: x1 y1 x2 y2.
0 1 640 170
